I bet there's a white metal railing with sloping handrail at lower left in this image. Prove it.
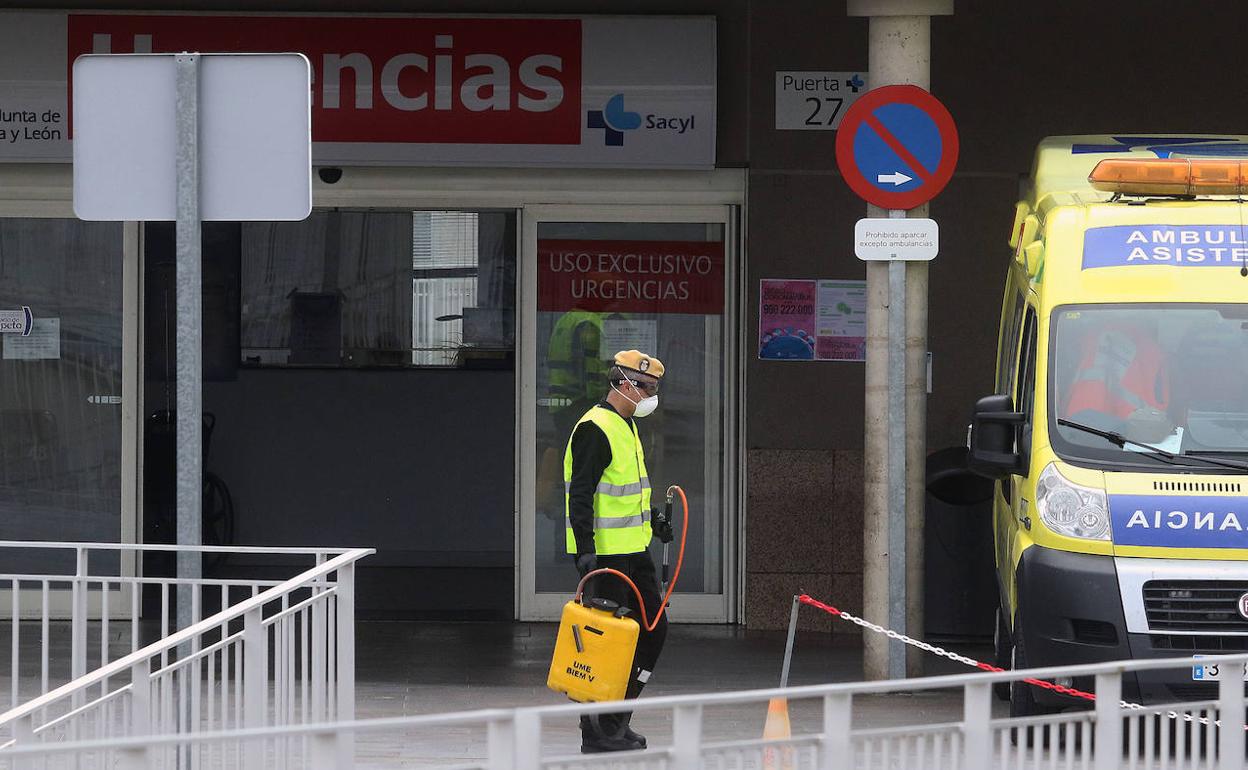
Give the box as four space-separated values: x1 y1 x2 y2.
0 543 373 766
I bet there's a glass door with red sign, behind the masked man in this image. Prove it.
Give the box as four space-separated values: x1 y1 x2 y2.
519 206 736 623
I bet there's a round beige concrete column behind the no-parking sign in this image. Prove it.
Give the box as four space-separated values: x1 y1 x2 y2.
847 0 953 679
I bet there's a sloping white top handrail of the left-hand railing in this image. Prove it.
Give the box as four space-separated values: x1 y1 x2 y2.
0 543 376 726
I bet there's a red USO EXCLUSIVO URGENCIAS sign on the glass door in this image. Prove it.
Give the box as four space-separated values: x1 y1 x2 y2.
538 238 724 316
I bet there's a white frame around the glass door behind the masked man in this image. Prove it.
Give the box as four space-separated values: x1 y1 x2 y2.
515 203 744 623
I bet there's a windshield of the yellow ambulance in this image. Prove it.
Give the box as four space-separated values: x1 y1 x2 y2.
1050 305 1248 470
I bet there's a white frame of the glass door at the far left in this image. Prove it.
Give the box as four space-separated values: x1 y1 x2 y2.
0 178 142 618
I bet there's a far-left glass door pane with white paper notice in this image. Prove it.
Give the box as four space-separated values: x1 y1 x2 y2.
0 209 137 581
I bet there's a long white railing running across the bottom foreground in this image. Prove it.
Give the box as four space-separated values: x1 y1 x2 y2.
0 655 1248 770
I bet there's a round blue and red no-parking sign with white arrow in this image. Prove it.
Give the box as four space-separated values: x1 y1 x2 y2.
836 86 958 210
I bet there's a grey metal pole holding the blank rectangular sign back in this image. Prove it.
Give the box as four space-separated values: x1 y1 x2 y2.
175 54 203 629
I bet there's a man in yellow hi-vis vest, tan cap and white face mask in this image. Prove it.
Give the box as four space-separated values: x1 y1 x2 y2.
563 351 673 754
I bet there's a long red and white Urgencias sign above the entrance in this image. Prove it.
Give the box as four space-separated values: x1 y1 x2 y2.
0 11 716 168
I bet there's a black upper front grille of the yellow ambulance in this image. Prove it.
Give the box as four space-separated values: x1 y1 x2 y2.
1144 580 1248 634
